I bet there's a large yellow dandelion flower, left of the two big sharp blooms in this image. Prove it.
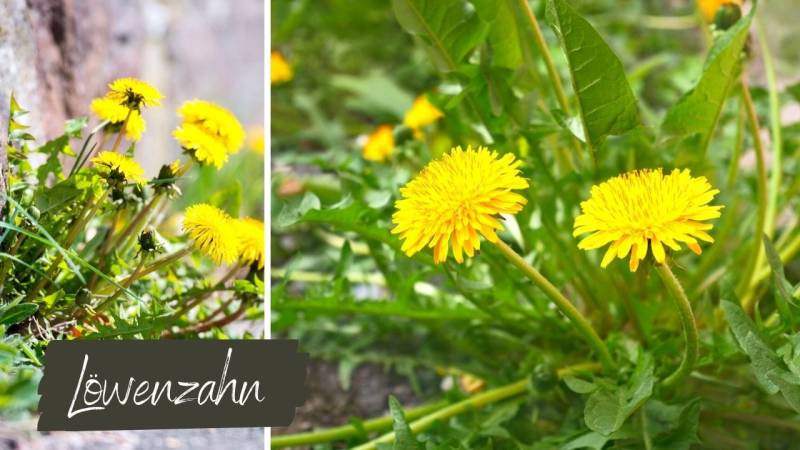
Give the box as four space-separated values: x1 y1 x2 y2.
392 147 528 263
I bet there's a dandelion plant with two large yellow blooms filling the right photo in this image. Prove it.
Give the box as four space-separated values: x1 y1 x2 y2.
271 0 800 450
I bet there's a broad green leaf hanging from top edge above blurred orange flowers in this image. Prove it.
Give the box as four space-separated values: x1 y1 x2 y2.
392 0 489 72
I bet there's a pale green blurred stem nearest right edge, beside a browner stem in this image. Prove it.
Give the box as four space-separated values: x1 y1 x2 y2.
756 15 783 241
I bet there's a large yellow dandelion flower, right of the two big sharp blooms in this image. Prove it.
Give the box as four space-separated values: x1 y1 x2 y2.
573 169 722 272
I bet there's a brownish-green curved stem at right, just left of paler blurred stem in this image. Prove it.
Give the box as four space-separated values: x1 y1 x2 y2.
738 78 768 313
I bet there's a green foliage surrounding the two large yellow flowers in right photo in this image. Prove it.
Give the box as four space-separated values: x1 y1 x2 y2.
270 0 800 449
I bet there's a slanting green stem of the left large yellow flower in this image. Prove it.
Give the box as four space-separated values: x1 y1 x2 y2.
494 239 616 373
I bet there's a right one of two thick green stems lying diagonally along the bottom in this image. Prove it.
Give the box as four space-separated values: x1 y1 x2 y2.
353 379 528 450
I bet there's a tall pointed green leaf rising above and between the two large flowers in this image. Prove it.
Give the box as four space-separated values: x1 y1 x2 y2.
547 0 641 149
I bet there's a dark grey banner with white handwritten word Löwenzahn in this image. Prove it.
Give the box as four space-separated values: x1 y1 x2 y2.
38 340 308 431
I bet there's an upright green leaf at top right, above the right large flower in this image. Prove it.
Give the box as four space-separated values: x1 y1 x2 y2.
661 6 756 150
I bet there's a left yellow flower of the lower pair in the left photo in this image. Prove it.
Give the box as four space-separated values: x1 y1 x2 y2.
183 203 239 264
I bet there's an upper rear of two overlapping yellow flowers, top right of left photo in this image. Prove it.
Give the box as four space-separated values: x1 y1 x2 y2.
178 100 245 153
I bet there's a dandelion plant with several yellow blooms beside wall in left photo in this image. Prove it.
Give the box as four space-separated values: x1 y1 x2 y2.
0 78 265 417
